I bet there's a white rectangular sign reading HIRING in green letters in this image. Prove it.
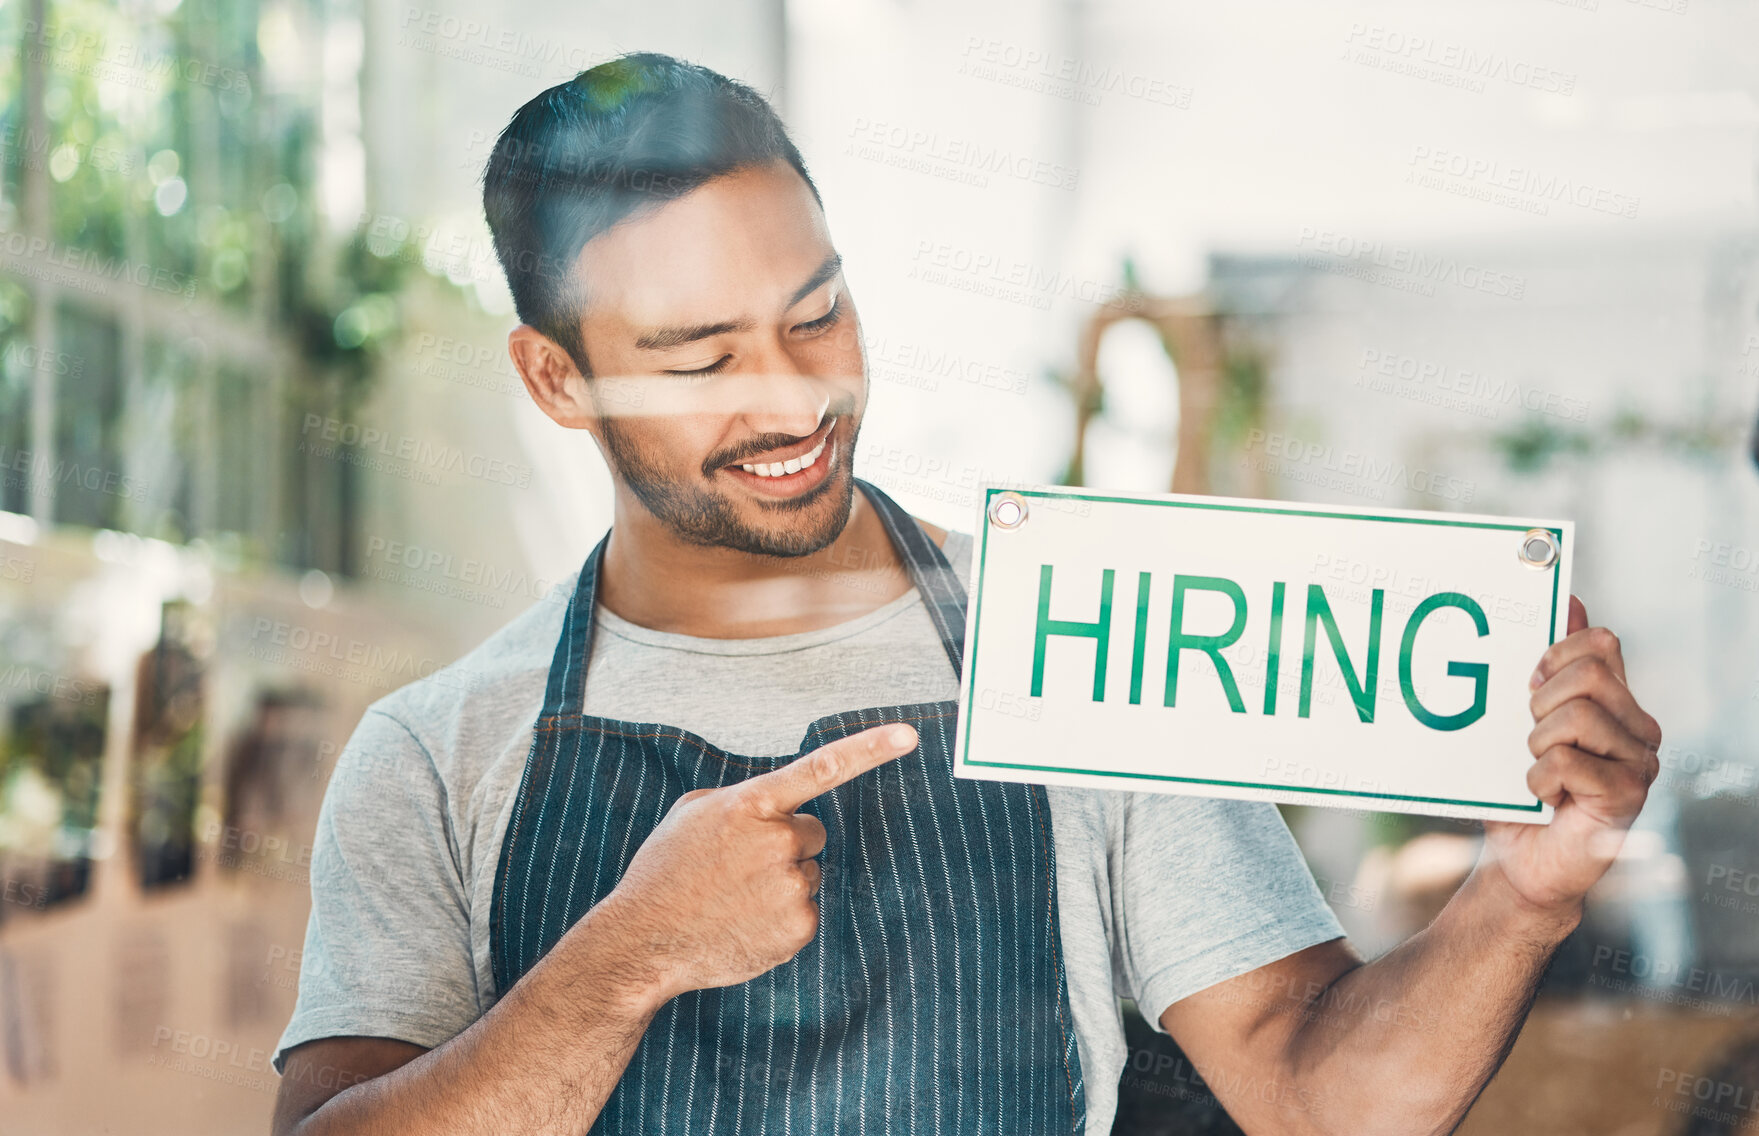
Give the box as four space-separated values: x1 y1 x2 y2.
953 485 1574 823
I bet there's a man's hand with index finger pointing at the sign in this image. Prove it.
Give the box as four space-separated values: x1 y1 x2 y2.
598 723 918 1001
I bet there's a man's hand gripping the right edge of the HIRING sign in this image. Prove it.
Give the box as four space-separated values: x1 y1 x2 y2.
1485 596 1660 913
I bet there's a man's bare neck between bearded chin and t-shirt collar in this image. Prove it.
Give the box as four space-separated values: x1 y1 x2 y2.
598 485 946 638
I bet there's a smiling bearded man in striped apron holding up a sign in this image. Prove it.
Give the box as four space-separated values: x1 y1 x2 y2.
274 55 1660 1136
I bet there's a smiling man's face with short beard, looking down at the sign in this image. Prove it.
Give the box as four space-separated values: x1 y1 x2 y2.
577 162 867 556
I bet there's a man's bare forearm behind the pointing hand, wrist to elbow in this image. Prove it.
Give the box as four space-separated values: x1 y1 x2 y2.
294 904 665 1136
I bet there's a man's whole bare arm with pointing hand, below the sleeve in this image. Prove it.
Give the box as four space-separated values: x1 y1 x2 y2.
274 726 916 1136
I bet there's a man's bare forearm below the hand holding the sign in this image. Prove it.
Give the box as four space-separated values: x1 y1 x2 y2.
1288 865 1581 1136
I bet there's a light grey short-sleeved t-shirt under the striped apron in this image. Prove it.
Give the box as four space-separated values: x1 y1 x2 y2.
274 533 1344 1136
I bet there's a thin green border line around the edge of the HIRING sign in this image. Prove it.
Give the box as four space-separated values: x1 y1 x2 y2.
960 485 1564 812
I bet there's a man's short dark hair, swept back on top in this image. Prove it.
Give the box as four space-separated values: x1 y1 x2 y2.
482 51 823 376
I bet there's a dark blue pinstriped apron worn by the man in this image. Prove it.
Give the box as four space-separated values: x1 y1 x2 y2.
489 478 1085 1136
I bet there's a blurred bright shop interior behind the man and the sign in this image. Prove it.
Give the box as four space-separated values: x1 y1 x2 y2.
0 0 1759 1136
